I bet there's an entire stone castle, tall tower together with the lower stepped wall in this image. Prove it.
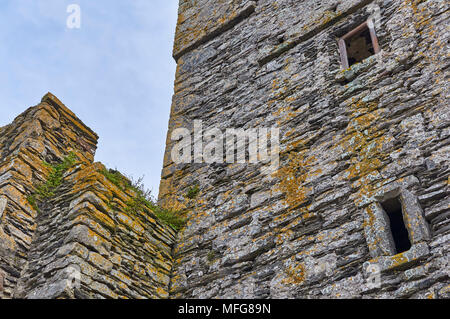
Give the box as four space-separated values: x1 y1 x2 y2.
0 0 450 299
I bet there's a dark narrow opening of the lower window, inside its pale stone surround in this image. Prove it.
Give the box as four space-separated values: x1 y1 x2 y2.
381 197 411 254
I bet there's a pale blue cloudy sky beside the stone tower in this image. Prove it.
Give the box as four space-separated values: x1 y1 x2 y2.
0 0 178 195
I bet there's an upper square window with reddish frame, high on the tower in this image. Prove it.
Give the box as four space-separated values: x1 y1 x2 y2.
339 19 380 69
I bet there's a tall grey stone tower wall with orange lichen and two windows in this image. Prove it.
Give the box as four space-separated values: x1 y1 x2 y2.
160 0 450 298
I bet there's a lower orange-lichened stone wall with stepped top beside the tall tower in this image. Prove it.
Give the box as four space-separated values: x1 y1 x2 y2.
0 94 175 298
